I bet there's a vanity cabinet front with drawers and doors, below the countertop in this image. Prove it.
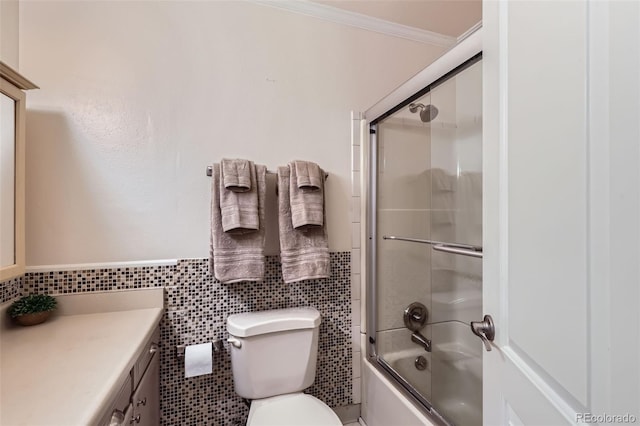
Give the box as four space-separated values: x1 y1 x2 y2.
100 328 160 426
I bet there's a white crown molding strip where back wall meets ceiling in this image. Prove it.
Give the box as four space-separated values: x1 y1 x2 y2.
250 0 457 47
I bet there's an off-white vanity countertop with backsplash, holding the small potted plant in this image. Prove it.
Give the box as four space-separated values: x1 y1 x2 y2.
0 289 163 426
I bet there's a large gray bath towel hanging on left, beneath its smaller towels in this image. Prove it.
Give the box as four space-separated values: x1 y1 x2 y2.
210 164 267 283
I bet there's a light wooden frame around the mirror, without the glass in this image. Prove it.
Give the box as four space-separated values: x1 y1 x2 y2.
0 61 38 281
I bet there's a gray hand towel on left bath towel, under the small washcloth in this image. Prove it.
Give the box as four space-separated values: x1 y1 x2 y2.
219 161 260 234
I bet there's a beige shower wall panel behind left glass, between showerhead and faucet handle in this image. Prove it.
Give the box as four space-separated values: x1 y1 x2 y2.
377 117 431 332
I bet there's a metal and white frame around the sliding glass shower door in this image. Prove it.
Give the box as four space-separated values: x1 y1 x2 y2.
362 25 482 425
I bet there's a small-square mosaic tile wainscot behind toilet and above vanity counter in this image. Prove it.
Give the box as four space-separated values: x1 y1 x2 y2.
23 252 353 426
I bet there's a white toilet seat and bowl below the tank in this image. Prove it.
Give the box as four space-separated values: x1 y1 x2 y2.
247 393 342 426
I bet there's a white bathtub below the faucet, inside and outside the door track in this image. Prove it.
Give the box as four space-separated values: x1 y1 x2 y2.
362 321 482 426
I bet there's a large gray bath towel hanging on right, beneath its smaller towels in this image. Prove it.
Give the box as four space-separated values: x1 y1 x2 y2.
278 166 331 283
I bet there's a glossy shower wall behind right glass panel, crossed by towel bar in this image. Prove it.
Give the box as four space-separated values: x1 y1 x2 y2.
431 63 482 323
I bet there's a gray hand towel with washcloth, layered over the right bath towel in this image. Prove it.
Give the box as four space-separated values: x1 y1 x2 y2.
289 161 324 230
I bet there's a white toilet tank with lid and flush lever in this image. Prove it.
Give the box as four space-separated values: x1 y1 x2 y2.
227 308 320 399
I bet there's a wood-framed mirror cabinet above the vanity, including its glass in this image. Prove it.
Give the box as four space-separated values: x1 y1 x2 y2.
0 62 38 281
